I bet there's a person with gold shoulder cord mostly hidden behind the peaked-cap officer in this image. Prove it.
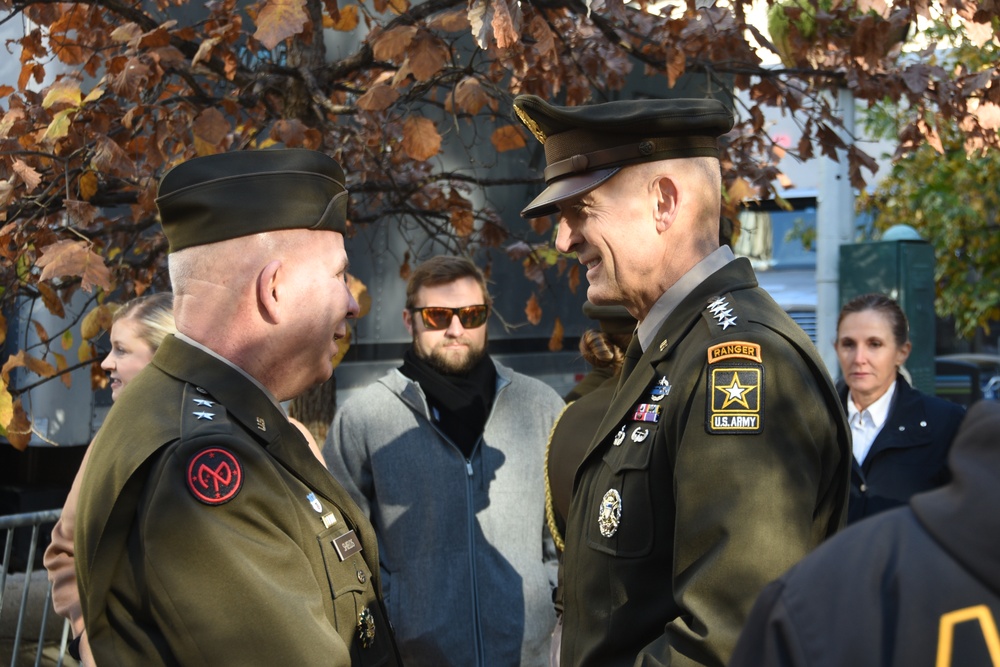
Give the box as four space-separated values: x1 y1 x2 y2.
545 301 636 667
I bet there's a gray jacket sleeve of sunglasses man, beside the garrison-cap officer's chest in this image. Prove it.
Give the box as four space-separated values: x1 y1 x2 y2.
323 402 374 519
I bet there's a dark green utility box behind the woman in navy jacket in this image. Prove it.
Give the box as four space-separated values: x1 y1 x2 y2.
840 236 937 396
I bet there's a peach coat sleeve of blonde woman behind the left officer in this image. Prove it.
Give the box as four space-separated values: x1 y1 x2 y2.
42 449 90 637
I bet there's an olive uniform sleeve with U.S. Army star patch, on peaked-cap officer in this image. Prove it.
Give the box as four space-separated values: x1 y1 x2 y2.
652 333 847 665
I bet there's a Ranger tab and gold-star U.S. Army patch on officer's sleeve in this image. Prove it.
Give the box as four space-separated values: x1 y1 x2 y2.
705 341 764 435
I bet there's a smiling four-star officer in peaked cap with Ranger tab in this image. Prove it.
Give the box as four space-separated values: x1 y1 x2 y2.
514 96 851 667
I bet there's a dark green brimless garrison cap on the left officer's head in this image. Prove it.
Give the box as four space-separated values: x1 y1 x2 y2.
156 148 348 252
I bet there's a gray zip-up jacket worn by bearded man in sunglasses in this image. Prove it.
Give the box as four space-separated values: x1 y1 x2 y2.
323 361 564 667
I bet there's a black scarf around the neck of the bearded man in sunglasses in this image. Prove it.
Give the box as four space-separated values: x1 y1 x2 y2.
399 347 497 458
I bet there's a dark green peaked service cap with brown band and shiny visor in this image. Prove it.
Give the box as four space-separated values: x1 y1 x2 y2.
514 95 733 218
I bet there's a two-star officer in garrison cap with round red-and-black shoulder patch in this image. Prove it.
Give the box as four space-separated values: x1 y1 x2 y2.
76 150 400 667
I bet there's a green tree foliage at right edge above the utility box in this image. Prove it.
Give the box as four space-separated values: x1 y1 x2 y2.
859 32 1000 338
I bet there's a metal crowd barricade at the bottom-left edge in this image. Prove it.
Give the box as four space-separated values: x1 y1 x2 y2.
0 509 72 667
